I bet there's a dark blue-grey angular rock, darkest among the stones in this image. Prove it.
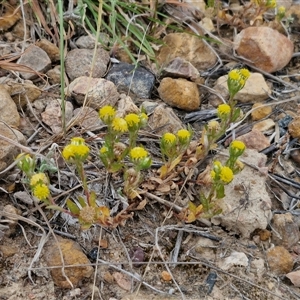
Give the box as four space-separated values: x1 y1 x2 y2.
106 63 155 98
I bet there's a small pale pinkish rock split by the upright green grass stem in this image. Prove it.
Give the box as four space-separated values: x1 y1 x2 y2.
41 99 73 133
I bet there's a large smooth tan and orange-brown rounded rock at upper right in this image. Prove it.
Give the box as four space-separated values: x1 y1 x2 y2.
234 26 294 73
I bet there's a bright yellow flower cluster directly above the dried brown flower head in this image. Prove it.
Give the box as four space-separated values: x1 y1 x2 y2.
62 137 90 162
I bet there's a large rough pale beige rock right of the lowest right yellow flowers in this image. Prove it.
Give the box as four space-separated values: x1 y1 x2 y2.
212 149 272 238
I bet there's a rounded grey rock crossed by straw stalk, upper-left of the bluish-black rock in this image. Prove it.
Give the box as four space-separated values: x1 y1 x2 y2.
65 48 110 81
